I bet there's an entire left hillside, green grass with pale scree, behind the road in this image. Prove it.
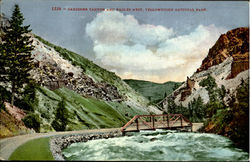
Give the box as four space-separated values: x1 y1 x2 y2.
0 14 162 134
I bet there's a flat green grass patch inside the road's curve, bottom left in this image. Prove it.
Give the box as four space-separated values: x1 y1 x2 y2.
8 137 54 160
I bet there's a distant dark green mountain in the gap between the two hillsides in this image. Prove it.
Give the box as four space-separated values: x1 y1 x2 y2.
124 79 182 103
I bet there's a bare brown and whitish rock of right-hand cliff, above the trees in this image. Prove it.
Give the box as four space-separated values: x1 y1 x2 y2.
159 28 249 109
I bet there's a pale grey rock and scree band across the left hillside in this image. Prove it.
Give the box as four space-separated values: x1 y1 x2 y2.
31 38 123 101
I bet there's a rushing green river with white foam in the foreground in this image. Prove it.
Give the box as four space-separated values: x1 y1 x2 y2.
63 130 249 161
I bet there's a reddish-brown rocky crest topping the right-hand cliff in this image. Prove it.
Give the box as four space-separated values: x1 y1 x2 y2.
196 28 249 79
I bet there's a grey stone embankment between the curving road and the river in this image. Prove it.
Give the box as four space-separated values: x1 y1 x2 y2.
50 130 122 160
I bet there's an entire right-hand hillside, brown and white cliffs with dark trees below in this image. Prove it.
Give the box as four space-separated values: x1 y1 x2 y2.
159 28 249 152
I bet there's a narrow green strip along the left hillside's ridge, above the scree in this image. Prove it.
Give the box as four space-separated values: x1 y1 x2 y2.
35 35 149 106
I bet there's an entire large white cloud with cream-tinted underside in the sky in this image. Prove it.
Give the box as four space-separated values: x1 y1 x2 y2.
86 11 226 82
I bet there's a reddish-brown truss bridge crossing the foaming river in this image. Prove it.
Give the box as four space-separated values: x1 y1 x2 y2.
121 114 193 135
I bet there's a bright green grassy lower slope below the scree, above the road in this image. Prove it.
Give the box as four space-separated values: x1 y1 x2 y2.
33 87 148 132
